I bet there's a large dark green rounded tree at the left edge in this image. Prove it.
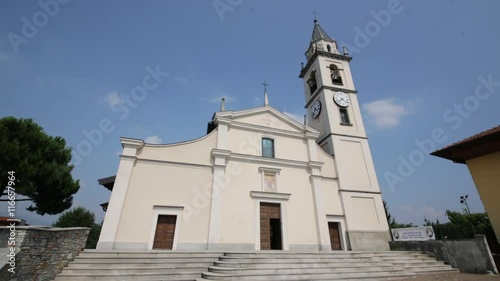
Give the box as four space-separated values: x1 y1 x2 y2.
0 117 80 215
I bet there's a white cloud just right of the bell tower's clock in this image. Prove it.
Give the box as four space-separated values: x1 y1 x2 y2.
362 98 415 129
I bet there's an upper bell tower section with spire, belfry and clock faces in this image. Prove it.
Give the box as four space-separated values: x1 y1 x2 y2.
299 19 366 155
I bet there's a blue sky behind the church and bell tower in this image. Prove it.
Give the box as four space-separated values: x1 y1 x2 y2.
0 0 500 224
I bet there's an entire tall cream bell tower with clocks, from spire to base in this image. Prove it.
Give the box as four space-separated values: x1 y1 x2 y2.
299 19 390 250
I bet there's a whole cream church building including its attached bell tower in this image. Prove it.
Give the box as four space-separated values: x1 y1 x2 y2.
97 20 391 251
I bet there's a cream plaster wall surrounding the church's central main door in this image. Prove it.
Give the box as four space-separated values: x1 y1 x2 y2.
217 162 318 245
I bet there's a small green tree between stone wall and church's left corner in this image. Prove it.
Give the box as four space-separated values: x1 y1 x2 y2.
52 207 102 249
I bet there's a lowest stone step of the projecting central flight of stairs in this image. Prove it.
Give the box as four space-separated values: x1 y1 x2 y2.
202 270 415 281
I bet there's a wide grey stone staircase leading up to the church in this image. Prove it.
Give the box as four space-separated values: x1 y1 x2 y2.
55 251 456 281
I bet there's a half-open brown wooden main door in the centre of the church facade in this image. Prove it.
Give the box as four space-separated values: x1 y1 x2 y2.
260 202 283 250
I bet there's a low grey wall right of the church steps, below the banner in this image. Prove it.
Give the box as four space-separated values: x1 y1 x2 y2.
389 235 498 274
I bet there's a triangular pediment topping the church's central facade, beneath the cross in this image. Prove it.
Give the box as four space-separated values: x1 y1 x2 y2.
215 106 317 133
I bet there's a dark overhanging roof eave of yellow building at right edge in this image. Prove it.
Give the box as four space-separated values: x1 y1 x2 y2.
431 126 500 163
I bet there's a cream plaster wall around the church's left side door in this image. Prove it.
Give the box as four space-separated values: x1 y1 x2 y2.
115 161 212 245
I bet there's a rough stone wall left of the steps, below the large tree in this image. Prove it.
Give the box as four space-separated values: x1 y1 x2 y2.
0 226 90 281
